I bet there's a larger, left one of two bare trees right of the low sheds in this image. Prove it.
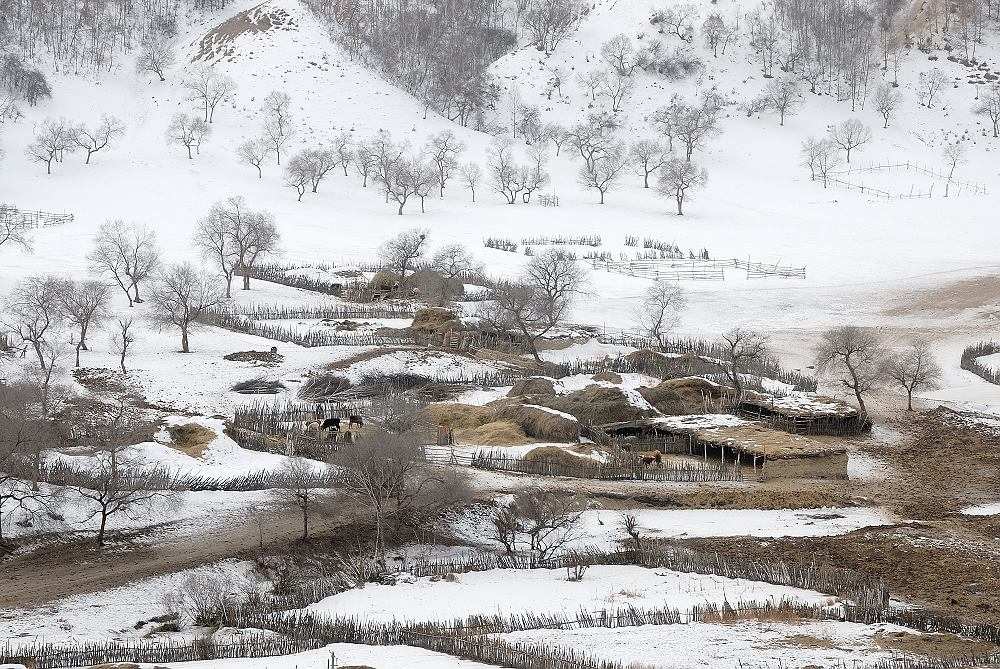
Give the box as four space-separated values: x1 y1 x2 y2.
816 325 888 413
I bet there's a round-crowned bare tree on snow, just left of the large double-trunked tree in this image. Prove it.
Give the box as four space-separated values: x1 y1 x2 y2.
87 220 160 307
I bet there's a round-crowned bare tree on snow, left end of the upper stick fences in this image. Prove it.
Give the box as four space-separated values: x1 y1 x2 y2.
150 263 225 353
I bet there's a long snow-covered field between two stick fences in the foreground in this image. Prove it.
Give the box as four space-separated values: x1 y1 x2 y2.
309 565 833 621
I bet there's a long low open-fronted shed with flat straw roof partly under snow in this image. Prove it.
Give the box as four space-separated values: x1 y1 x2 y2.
602 414 847 479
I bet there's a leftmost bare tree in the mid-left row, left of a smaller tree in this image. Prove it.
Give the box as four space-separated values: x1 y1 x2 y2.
5 275 61 372
